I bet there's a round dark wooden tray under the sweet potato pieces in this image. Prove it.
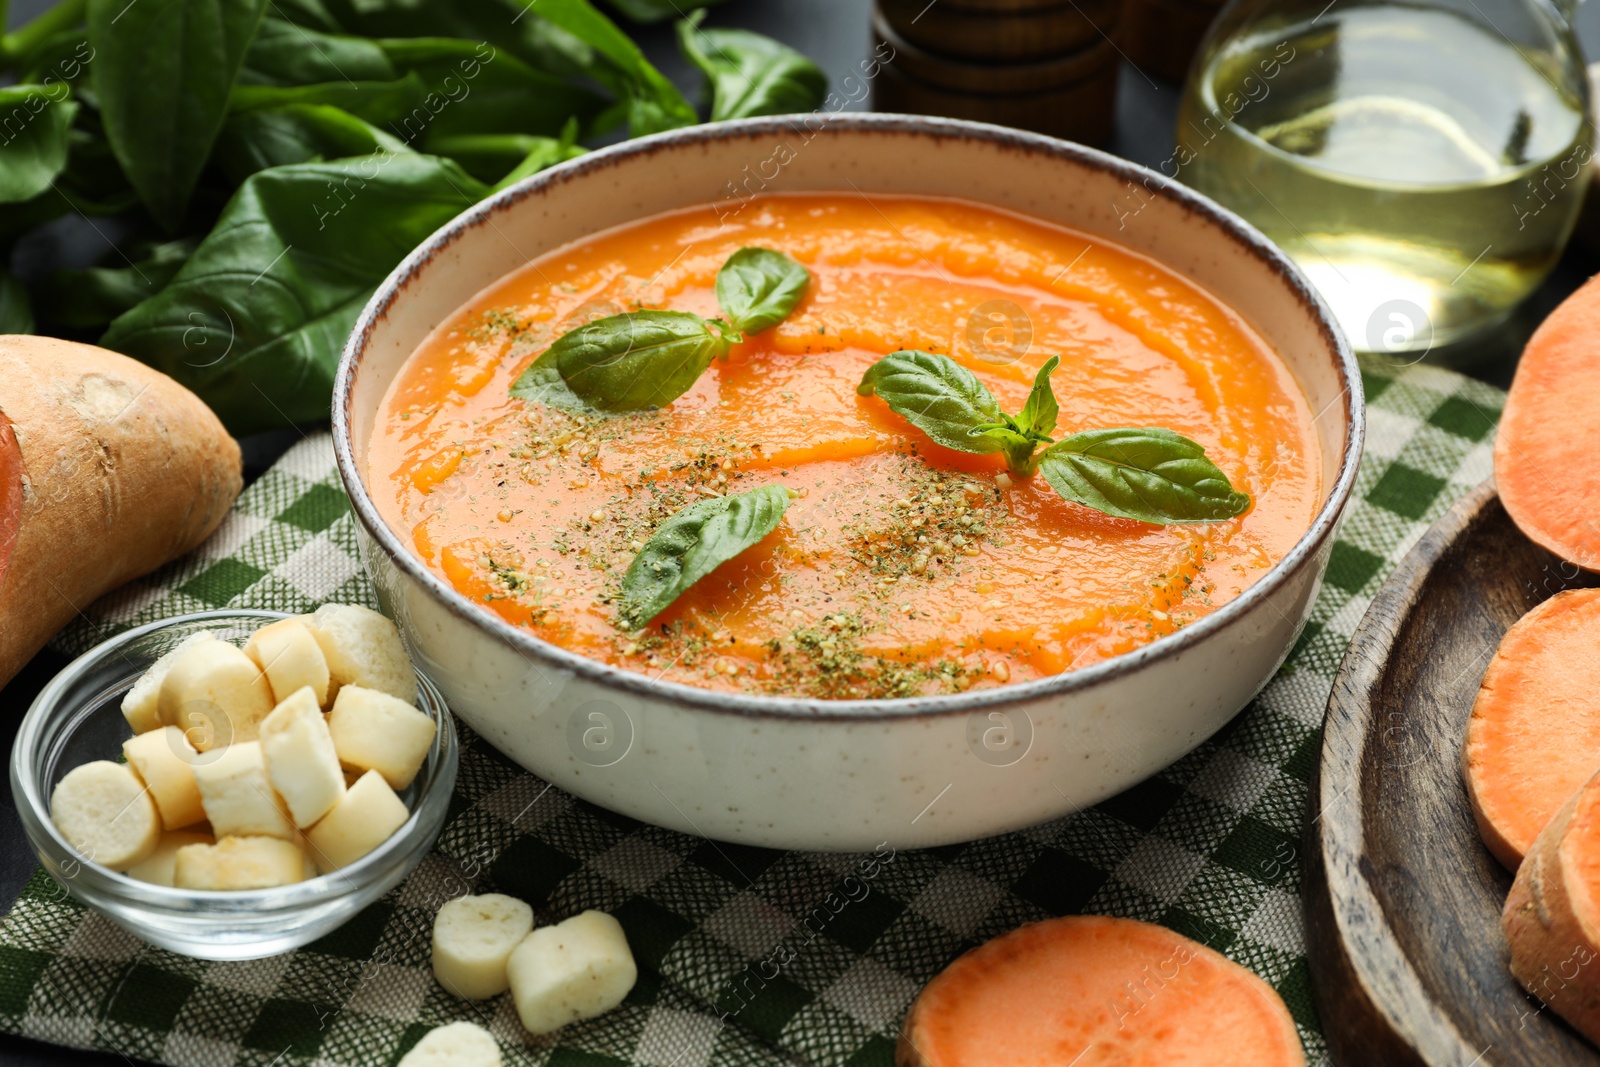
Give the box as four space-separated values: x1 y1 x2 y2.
1306 483 1600 1067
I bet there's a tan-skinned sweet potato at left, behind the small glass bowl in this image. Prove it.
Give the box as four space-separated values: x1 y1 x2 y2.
0 336 242 686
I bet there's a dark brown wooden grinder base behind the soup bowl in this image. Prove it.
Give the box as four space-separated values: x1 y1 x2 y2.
872 0 1122 144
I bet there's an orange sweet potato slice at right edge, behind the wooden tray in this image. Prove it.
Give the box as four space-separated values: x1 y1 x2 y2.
1494 277 1600 571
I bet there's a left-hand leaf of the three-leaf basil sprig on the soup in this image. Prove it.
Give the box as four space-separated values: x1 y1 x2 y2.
856 349 1006 453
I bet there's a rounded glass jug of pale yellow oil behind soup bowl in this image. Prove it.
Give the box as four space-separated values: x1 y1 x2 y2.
1166 0 1594 352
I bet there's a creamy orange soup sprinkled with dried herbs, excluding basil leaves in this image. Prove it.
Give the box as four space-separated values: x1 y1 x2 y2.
368 195 1322 699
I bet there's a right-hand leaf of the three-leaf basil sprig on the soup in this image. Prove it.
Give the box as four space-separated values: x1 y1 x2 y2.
1038 427 1250 526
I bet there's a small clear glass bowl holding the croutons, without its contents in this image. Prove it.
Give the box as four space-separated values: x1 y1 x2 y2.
11 611 459 960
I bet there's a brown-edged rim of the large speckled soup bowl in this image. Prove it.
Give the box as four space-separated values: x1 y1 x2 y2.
333 114 1366 721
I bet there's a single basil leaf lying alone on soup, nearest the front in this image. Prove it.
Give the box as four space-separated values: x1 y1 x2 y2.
618 485 789 630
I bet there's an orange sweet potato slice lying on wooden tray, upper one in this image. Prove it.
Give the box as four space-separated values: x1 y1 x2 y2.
1461 589 1600 870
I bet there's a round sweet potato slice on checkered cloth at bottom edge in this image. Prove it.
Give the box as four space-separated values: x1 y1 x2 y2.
894 915 1306 1067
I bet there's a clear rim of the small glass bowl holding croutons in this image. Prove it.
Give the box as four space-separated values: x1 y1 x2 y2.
10 608 461 917
